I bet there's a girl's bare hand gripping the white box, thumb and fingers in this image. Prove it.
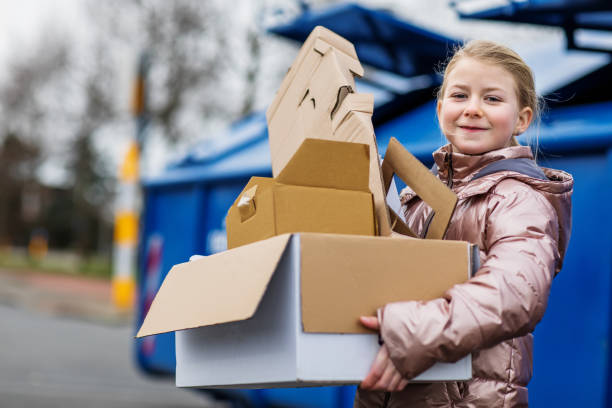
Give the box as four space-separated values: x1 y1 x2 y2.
359 316 408 391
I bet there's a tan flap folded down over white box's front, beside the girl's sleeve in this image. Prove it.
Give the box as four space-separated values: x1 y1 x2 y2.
300 234 470 333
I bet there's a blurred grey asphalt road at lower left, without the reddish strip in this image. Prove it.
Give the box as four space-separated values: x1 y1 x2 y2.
0 305 224 408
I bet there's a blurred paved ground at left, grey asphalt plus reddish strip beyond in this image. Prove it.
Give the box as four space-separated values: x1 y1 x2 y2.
0 269 227 408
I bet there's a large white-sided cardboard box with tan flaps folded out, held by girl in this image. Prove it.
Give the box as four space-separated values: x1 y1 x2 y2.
138 234 478 388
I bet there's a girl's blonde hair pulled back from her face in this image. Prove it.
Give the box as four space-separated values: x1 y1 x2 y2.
437 40 543 146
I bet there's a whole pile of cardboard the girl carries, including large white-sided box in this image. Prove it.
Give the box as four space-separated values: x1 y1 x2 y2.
138 27 478 388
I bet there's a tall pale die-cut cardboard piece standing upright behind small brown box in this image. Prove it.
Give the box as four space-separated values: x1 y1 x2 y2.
266 26 391 236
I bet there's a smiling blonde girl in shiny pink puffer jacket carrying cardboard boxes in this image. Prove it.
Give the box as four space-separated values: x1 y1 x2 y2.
355 41 573 407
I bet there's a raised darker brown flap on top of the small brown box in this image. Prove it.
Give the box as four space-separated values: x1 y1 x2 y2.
275 139 370 192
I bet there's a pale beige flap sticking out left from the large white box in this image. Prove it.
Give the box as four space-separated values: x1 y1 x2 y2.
136 234 291 337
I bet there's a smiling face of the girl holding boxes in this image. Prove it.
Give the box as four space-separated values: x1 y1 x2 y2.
437 57 533 154
